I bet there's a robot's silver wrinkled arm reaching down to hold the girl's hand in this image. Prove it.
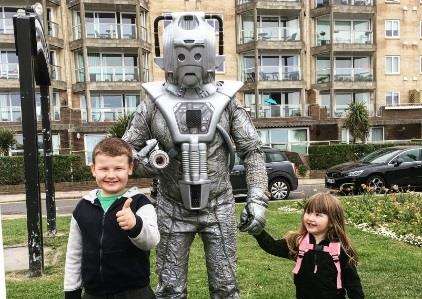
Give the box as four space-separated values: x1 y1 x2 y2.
229 99 268 234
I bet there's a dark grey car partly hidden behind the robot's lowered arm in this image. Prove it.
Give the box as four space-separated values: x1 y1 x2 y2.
230 147 298 199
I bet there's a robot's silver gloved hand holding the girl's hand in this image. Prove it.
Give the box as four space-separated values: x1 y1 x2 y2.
239 188 268 235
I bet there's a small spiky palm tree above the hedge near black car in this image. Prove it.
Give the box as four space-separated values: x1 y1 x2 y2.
344 102 369 143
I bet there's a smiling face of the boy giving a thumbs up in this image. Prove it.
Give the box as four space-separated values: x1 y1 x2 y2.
91 154 133 196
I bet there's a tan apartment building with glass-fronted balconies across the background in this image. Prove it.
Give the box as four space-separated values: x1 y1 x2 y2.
0 0 422 163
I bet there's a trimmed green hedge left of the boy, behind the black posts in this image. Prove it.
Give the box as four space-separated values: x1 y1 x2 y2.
0 155 92 185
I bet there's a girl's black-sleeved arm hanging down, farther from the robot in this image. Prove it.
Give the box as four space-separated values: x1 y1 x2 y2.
340 248 365 299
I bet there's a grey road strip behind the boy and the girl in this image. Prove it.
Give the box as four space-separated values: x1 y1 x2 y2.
0 184 327 217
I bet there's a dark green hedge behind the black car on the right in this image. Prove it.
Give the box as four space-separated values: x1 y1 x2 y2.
308 143 420 170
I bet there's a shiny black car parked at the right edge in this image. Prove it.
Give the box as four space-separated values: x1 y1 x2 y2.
325 146 422 192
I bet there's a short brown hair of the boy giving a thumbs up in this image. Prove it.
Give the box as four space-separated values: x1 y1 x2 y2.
92 137 133 164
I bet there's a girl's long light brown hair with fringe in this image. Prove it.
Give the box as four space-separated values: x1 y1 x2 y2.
286 192 357 265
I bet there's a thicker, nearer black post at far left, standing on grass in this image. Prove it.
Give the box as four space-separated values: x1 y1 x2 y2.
13 14 44 277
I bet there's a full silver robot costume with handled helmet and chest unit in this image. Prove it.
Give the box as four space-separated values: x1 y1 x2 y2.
123 12 268 298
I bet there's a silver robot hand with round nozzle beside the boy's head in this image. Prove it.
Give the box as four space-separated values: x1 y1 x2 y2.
133 139 170 174
